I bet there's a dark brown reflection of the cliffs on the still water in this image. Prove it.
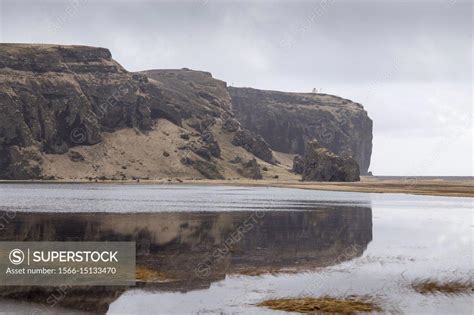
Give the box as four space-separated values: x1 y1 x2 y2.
0 207 372 312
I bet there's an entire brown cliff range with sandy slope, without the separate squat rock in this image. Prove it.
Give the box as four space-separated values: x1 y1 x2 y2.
0 44 372 180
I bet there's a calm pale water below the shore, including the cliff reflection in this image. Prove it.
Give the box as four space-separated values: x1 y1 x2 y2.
0 184 474 314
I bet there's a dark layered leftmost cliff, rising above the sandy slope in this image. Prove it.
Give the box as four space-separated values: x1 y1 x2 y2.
0 44 162 179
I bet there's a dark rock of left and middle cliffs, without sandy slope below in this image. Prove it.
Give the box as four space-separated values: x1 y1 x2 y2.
0 44 271 179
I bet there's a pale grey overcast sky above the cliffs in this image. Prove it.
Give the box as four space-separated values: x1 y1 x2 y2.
0 0 474 176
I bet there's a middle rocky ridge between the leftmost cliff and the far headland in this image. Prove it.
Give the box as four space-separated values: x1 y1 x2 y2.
141 69 274 163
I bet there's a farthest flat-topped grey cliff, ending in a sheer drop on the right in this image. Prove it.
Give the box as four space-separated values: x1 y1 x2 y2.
228 87 372 174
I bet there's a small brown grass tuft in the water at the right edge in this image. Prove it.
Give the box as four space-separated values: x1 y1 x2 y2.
411 279 474 295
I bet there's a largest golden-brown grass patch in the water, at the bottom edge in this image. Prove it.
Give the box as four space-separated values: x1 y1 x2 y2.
257 296 382 314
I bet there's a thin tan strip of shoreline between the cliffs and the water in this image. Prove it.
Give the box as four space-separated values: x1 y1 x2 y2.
0 176 474 197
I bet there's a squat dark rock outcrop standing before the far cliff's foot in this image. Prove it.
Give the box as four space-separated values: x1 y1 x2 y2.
293 140 360 182
